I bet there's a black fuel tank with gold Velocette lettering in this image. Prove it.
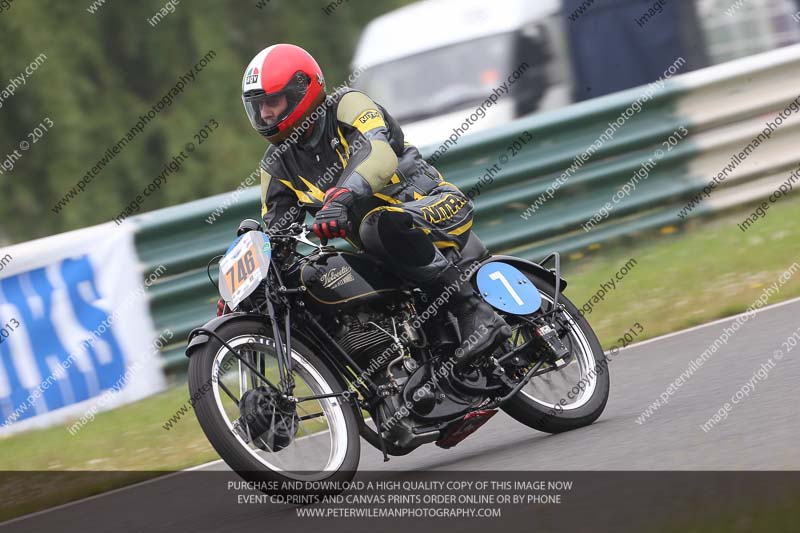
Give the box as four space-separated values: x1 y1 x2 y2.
299 252 406 309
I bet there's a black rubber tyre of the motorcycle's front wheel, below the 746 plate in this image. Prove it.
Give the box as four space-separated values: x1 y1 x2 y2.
189 320 361 483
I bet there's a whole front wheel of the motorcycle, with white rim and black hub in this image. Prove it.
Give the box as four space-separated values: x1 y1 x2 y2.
189 319 360 482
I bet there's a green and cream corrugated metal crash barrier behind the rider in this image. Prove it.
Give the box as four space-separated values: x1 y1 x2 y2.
131 45 800 373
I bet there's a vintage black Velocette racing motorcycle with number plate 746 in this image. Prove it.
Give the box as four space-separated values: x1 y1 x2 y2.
186 220 609 482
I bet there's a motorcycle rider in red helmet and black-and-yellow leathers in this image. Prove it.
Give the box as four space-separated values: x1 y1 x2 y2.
228 44 511 364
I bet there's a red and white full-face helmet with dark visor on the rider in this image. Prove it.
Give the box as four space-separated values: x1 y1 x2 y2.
242 44 325 143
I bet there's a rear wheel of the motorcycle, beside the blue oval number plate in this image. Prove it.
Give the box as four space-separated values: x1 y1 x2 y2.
502 272 610 433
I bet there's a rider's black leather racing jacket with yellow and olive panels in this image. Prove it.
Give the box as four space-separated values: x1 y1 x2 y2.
261 89 442 231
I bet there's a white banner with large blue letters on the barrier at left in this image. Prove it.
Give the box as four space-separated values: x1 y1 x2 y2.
0 223 166 435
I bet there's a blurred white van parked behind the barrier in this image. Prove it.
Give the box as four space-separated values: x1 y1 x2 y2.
352 0 572 146
